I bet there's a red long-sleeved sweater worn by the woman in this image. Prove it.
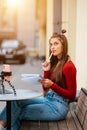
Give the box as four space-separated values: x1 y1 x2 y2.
44 61 76 100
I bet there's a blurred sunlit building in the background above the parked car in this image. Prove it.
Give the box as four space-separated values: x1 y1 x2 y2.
0 0 46 56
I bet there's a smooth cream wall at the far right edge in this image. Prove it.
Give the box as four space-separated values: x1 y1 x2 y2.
76 0 87 89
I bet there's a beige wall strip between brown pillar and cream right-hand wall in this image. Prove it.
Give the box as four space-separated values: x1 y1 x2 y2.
62 0 76 63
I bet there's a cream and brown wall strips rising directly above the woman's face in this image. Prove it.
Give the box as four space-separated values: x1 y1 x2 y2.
46 0 62 58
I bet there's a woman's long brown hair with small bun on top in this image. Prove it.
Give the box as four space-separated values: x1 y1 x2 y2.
49 30 69 87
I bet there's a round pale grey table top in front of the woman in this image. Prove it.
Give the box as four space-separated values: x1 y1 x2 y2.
0 89 43 101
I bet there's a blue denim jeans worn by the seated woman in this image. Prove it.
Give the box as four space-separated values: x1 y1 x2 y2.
0 91 69 130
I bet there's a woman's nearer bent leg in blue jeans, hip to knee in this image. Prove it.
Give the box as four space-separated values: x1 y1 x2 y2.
19 98 68 120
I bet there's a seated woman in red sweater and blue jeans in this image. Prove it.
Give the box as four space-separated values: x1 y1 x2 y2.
0 30 76 130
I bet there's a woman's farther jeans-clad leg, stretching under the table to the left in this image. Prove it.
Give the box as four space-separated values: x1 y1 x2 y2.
0 98 43 130
